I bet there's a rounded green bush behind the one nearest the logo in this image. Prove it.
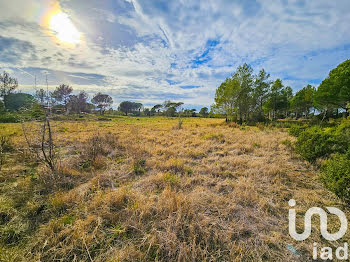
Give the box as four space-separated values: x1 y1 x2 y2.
295 126 335 163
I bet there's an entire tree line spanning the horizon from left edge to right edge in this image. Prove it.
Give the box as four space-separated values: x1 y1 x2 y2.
0 60 350 123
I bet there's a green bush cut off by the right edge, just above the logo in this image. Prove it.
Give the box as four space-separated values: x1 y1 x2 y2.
321 154 350 203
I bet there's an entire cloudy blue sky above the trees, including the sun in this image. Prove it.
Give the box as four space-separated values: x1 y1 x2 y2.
0 0 350 109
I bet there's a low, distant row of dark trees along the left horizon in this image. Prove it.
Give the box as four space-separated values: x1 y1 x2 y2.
0 72 209 117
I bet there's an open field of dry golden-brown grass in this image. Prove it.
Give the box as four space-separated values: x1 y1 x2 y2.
0 117 350 261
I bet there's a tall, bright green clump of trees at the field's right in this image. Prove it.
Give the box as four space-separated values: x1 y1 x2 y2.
212 60 350 123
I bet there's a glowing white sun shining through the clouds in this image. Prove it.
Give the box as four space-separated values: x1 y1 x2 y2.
49 12 80 44
